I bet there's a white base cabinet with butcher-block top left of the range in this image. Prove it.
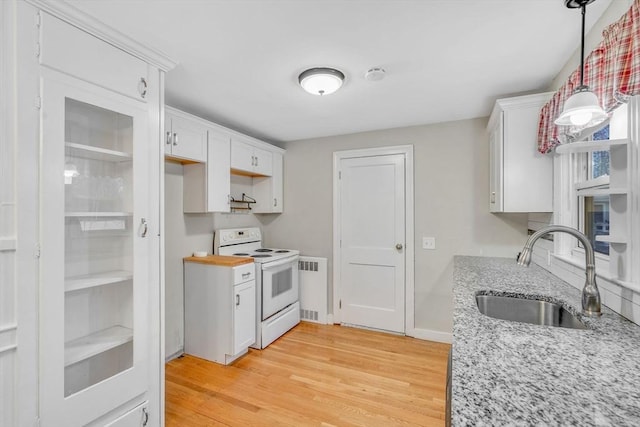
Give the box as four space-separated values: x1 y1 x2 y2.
184 256 256 365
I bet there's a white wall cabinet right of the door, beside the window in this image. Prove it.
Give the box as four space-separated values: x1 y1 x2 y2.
488 93 553 212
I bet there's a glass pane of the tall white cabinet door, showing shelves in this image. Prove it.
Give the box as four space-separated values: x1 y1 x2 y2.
61 98 134 397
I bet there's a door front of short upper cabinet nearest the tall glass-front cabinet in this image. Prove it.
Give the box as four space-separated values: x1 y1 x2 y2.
165 113 207 162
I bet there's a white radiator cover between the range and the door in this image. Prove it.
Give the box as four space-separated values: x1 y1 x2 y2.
298 256 327 324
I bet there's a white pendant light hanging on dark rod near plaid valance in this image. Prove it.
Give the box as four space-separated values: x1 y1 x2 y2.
554 0 607 127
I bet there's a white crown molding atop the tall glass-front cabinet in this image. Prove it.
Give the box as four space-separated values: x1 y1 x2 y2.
25 0 178 72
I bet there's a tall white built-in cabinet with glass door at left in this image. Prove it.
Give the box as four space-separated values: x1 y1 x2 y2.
32 6 172 427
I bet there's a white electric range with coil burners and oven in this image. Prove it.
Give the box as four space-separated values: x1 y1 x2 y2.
213 227 300 349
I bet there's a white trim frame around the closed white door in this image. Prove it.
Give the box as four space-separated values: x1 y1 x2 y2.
330 145 415 337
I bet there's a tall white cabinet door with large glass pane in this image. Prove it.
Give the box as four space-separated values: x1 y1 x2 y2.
39 69 150 426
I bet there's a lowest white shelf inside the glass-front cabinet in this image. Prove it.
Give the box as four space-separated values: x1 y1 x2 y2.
64 326 133 367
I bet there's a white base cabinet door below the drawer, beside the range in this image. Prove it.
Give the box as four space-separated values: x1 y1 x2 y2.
233 280 256 355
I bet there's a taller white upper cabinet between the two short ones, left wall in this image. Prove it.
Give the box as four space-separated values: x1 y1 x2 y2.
183 127 231 213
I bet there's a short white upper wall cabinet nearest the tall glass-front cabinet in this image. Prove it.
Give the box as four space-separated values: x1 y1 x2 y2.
164 107 207 163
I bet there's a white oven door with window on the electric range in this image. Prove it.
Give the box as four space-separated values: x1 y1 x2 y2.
261 255 299 320
